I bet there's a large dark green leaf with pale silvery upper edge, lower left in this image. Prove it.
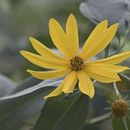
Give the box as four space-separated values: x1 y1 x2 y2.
0 76 62 130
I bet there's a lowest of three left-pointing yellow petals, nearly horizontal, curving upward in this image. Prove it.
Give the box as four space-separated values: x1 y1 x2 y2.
27 69 71 79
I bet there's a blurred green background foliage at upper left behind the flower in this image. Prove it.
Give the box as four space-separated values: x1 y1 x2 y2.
0 0 87 82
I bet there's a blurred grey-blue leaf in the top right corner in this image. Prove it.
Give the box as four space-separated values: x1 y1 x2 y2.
80 0 130 32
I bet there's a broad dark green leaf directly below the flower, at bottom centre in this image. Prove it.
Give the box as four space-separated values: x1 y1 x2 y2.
34 95 89 130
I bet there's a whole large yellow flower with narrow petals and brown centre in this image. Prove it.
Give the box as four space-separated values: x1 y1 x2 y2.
20 14 130 98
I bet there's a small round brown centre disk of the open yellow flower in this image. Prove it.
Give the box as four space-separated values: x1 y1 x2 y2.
70 56 84 71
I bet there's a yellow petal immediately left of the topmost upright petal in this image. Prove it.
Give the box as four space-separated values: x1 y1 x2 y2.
49 19 72 59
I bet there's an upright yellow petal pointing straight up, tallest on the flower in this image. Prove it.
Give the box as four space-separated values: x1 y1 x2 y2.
66 14 79 57
